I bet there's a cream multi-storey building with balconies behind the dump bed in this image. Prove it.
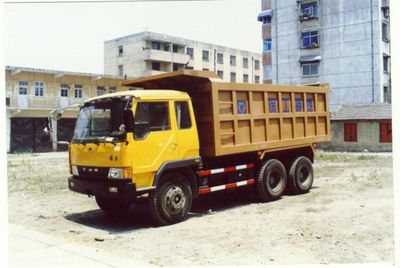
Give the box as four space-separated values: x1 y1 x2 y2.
104 32 263 83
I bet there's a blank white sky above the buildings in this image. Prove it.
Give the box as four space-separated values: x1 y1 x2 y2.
4 0 262 73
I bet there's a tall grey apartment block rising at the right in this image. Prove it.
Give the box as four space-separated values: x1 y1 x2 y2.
258 0 391 110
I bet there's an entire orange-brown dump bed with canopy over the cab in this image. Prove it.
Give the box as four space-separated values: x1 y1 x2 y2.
122 70 330 157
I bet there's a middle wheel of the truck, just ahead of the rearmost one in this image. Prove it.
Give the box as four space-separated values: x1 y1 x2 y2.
256 159 287 202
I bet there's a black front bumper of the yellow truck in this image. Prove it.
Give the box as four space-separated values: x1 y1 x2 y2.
68 177 138 202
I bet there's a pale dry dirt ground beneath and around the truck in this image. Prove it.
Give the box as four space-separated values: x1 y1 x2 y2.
8 152 394 266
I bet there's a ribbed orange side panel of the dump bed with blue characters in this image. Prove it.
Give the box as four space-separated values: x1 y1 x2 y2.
210 82 330 156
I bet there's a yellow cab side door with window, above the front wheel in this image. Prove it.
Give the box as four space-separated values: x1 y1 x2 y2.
132 101 178 188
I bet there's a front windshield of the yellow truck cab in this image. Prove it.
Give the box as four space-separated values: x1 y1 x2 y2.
72 97 132 142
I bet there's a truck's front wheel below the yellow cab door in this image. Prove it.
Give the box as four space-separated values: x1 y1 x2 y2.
149 173 192 225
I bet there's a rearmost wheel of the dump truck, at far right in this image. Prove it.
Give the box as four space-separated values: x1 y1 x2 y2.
288 156 314 194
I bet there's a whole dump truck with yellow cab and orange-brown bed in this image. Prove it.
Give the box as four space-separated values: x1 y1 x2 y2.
63 70 330 225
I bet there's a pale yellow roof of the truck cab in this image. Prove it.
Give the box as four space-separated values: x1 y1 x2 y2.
85 89 190 102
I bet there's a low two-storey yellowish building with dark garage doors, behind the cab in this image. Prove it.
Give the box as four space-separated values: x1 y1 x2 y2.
5 66 126 152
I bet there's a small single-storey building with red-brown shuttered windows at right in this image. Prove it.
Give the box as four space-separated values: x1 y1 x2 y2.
319 103 392 152
